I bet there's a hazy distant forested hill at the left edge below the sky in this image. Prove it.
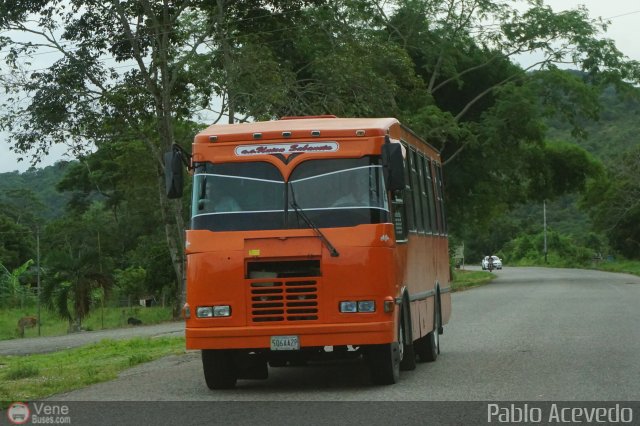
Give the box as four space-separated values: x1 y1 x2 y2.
0 161 70 221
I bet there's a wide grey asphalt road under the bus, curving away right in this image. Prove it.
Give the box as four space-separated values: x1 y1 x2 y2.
48 267 640 401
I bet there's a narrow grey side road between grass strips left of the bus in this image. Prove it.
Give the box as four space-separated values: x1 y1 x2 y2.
0 321 184 355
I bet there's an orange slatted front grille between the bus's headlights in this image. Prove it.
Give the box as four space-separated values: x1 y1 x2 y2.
250 279 318 323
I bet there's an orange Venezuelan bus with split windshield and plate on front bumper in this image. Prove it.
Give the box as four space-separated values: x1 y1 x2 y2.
165 116 451 389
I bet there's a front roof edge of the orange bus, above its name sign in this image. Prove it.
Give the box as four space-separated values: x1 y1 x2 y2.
195 116 398 143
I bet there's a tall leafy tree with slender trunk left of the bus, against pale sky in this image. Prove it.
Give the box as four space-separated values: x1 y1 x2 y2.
0 0 336 312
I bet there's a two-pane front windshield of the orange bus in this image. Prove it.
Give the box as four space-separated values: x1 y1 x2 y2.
191 157 389 231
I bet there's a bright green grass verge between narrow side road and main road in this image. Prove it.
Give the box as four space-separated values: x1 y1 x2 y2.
0 337 185 408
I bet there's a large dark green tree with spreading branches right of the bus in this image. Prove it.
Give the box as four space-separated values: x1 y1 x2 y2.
380 0 639 236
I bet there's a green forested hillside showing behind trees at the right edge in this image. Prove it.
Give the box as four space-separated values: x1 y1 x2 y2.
549 87 640 164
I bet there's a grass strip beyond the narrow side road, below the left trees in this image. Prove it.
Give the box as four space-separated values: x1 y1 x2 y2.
0 306 172 340
